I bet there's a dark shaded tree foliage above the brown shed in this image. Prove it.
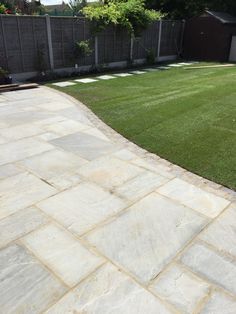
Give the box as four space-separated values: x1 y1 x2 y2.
146 0 236 19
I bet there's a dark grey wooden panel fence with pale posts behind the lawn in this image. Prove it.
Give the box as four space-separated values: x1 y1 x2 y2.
0 15 184 74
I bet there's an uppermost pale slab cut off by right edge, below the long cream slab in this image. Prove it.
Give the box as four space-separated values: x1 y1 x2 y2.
200 204 236 257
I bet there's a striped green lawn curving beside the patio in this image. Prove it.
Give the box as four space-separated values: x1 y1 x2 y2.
48 67 236 189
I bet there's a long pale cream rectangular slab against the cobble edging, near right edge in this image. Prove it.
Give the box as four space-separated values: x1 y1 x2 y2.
158 178 229 218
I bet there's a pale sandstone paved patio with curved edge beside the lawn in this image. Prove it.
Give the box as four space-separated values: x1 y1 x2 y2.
0 87 236 314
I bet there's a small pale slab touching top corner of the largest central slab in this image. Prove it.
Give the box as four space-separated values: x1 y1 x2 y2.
114 171 169 201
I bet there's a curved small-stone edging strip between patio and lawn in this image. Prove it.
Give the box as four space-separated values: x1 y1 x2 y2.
40 85 236 202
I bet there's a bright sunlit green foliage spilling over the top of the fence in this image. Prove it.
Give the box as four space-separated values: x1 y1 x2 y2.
82 0 161 35
